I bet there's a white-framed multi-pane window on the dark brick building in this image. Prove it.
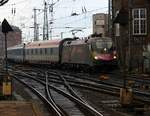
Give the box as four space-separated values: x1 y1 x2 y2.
132 8 147 35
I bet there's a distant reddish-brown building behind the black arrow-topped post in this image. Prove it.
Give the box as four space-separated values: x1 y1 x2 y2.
0 26 22 59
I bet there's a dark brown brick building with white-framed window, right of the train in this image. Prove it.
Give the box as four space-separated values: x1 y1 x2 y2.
111 0 150 71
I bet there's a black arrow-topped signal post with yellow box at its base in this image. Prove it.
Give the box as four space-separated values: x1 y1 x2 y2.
2 19 13 96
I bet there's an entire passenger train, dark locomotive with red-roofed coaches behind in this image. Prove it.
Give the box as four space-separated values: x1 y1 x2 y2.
7 36 117 67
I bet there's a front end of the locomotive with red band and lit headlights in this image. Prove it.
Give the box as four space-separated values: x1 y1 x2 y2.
91 37 117 65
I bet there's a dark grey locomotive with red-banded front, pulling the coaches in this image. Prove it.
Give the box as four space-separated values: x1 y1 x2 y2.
61 37 117 67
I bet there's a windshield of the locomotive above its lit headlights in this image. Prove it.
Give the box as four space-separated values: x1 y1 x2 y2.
92 38 112 52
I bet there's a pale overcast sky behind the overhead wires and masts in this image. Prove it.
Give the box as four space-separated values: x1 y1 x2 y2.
0 0 108 41
